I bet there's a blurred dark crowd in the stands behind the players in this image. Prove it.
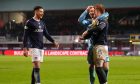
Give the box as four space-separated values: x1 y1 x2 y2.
0 9 140 37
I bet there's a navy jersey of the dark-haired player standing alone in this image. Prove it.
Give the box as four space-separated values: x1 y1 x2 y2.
23 18 54 49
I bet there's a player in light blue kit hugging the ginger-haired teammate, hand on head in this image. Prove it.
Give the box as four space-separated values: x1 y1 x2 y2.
78 6 109 84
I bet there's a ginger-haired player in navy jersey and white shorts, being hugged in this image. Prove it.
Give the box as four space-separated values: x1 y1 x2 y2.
82 4 109 84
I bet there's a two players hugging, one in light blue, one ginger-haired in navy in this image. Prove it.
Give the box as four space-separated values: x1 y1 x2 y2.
78 4 109 84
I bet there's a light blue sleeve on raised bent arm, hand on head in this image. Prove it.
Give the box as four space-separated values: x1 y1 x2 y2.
78 10 89 26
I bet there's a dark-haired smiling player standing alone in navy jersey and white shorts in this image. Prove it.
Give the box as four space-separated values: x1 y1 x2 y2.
23 6 59 84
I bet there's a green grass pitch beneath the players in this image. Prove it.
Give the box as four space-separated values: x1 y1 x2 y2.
0 56 140 84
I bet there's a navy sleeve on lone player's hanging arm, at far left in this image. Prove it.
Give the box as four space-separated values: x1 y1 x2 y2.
23 21 30 48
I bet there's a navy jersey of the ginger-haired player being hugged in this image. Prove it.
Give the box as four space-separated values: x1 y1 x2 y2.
88 20 108 45
